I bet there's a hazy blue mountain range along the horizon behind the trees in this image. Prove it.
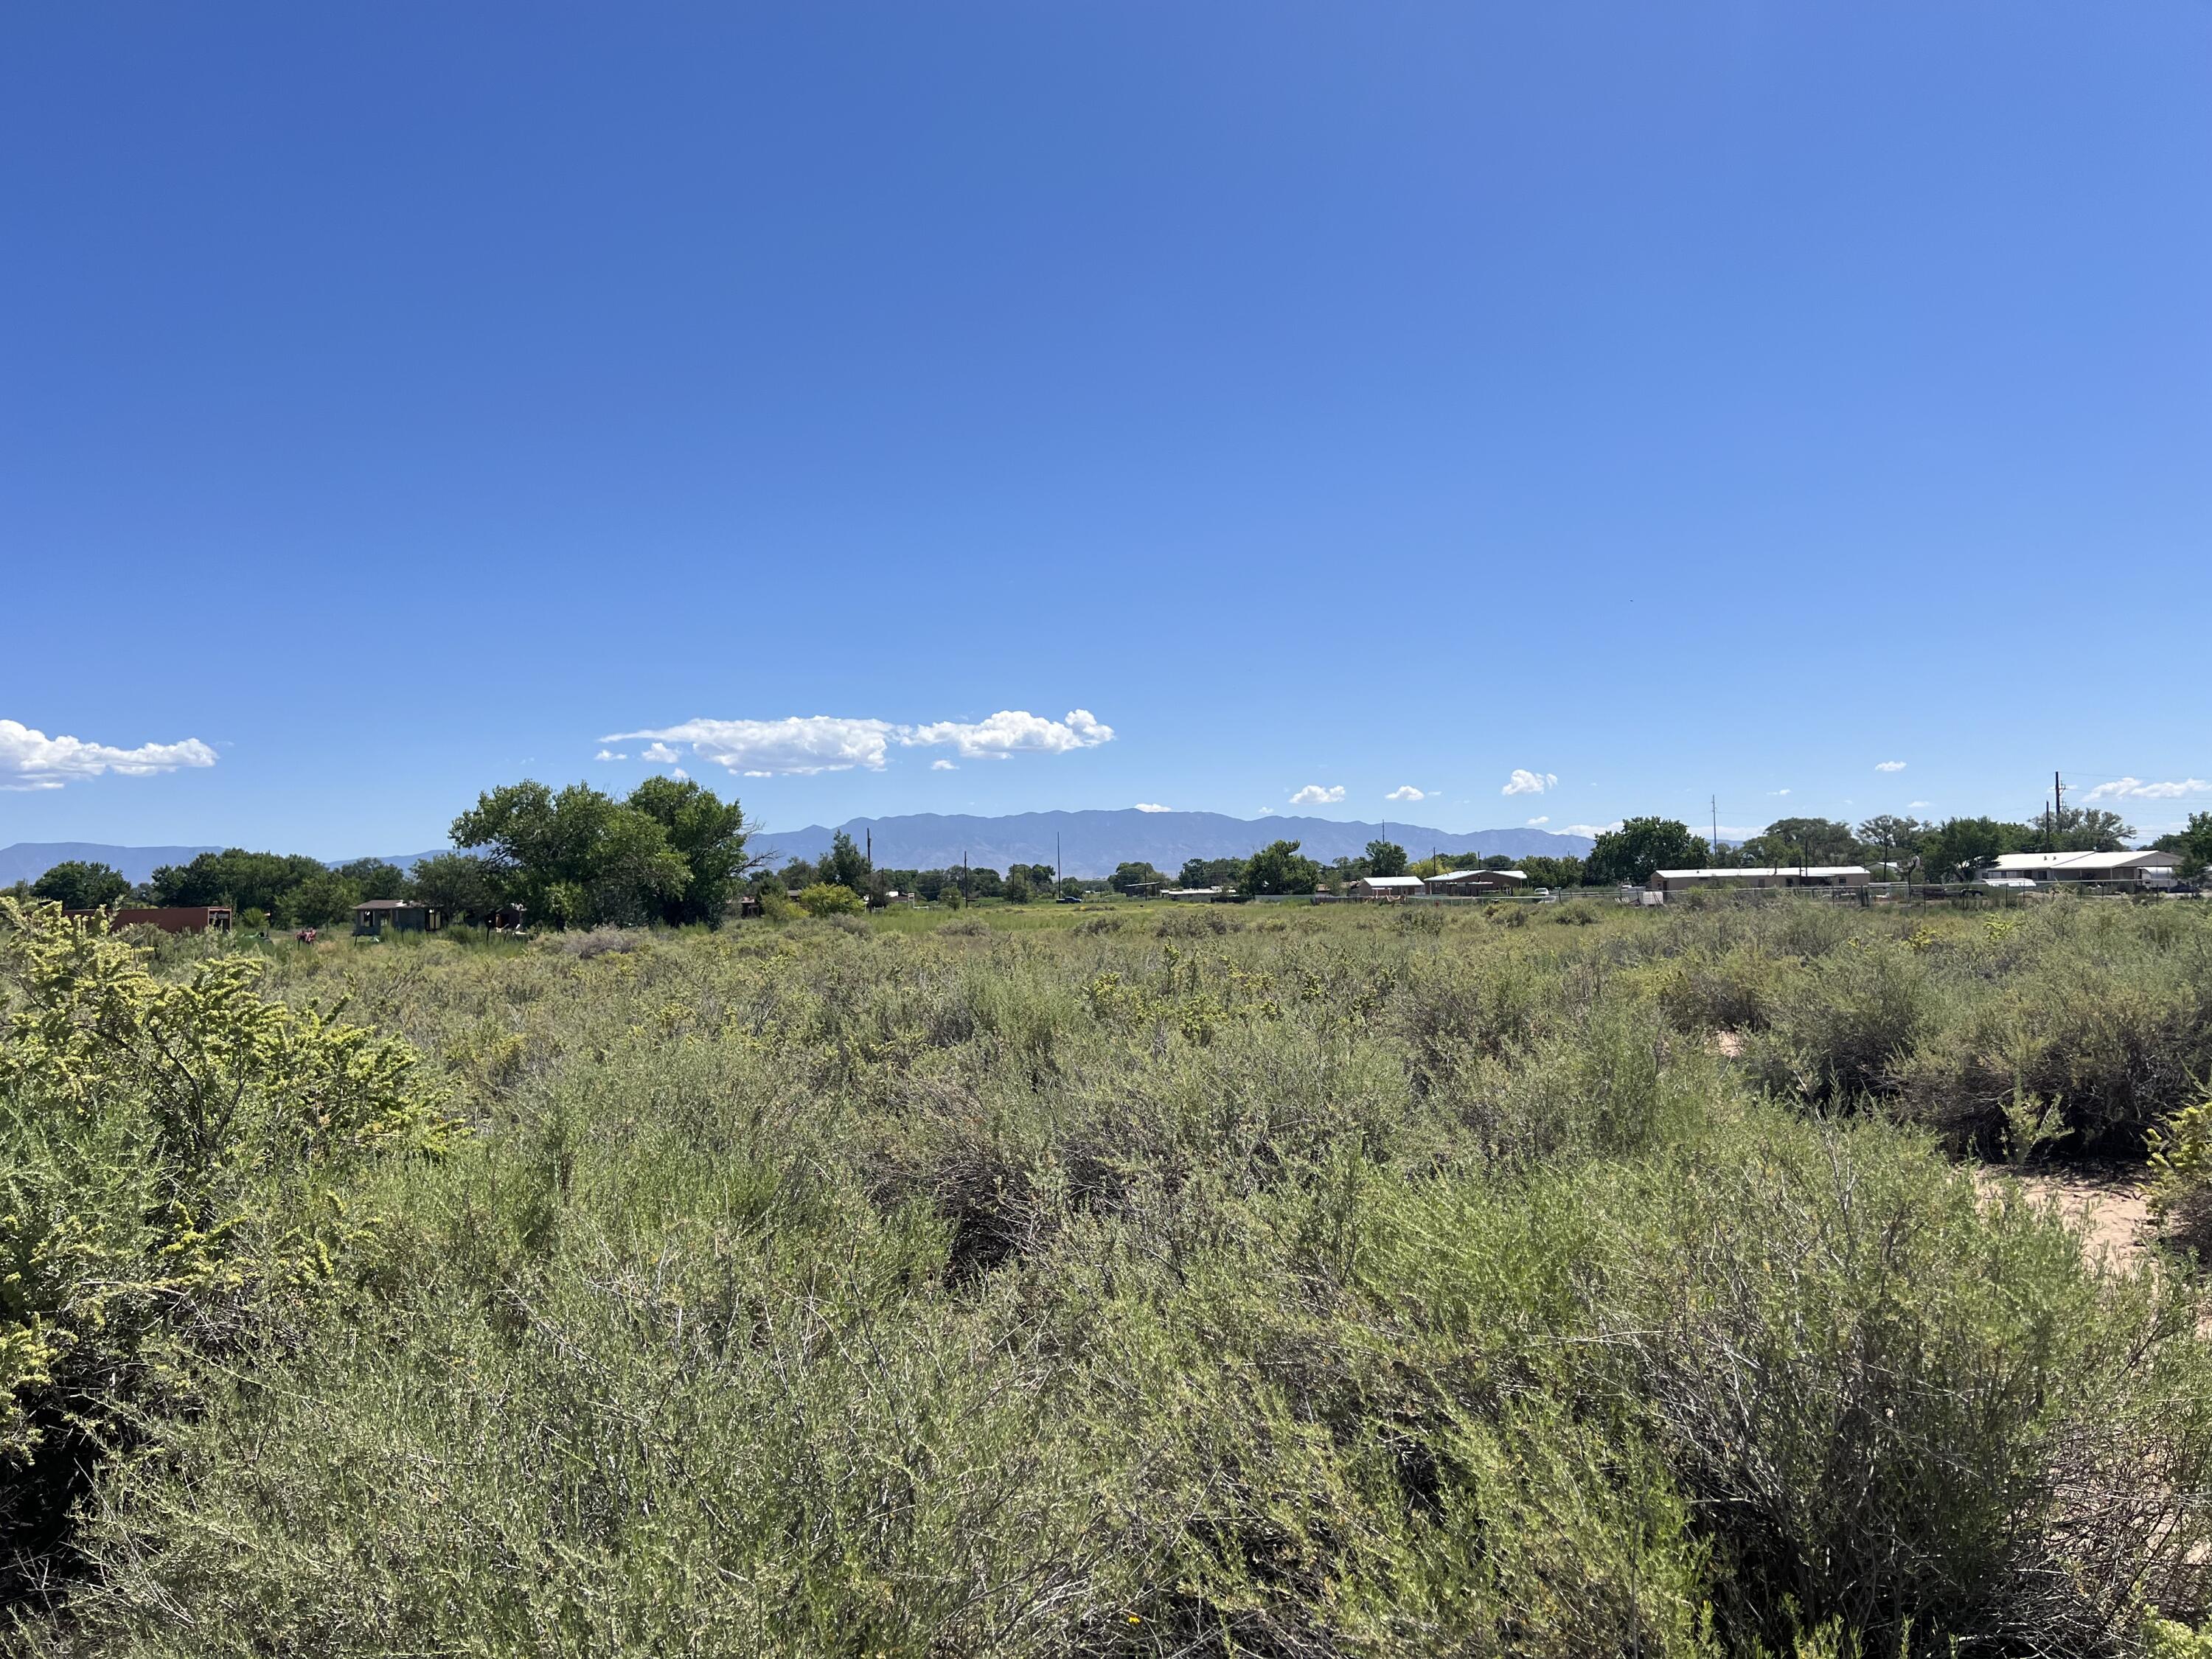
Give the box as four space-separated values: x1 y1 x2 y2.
0 807 1590 887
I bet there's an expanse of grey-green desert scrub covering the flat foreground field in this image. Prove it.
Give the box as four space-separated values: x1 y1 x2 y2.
0 902 2212 1659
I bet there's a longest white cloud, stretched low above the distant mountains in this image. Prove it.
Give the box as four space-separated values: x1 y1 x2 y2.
599 708 1113 779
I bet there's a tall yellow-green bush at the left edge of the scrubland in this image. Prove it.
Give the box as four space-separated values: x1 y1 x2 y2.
0 900 453 1593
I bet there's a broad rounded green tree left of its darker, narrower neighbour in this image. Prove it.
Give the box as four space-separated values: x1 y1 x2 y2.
453 781 690 927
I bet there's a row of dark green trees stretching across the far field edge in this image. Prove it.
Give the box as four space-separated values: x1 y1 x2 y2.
13 796 2212 927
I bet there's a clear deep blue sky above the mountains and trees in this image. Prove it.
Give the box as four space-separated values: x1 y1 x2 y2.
0 0 2212 856
